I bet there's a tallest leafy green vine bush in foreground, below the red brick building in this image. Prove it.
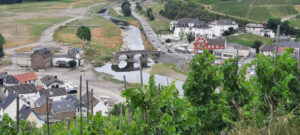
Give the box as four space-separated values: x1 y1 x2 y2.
183 50 225 134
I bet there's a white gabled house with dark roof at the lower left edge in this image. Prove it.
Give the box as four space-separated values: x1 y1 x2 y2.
0 93 27 120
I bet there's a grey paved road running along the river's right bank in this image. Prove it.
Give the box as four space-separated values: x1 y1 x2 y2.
131 2 192 60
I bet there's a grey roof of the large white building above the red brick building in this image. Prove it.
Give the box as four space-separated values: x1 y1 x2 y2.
176 18 208 28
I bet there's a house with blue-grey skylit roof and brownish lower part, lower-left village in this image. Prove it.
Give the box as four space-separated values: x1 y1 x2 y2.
51 100 76 120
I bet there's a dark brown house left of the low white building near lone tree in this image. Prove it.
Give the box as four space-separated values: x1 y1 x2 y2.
30 48 53 70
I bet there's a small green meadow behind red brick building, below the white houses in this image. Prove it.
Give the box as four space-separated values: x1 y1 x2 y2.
228 34 273 47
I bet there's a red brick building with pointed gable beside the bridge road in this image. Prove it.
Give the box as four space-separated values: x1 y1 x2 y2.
194 37 226 54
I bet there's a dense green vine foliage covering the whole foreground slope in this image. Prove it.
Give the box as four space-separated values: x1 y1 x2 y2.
0 49 300 135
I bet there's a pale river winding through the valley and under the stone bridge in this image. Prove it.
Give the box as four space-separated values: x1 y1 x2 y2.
95 12 183 96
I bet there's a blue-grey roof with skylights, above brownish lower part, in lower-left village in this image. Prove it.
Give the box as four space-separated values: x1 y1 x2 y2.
51 100 76 113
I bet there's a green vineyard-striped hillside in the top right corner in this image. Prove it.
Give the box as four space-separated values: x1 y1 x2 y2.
198 0 300 22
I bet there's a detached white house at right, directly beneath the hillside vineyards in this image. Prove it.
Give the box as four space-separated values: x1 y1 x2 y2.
246 23 275 38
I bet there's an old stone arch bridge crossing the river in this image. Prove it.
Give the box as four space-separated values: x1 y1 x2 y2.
111 50 164 64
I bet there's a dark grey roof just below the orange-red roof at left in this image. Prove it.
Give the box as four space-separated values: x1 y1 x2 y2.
5 84 37 94
